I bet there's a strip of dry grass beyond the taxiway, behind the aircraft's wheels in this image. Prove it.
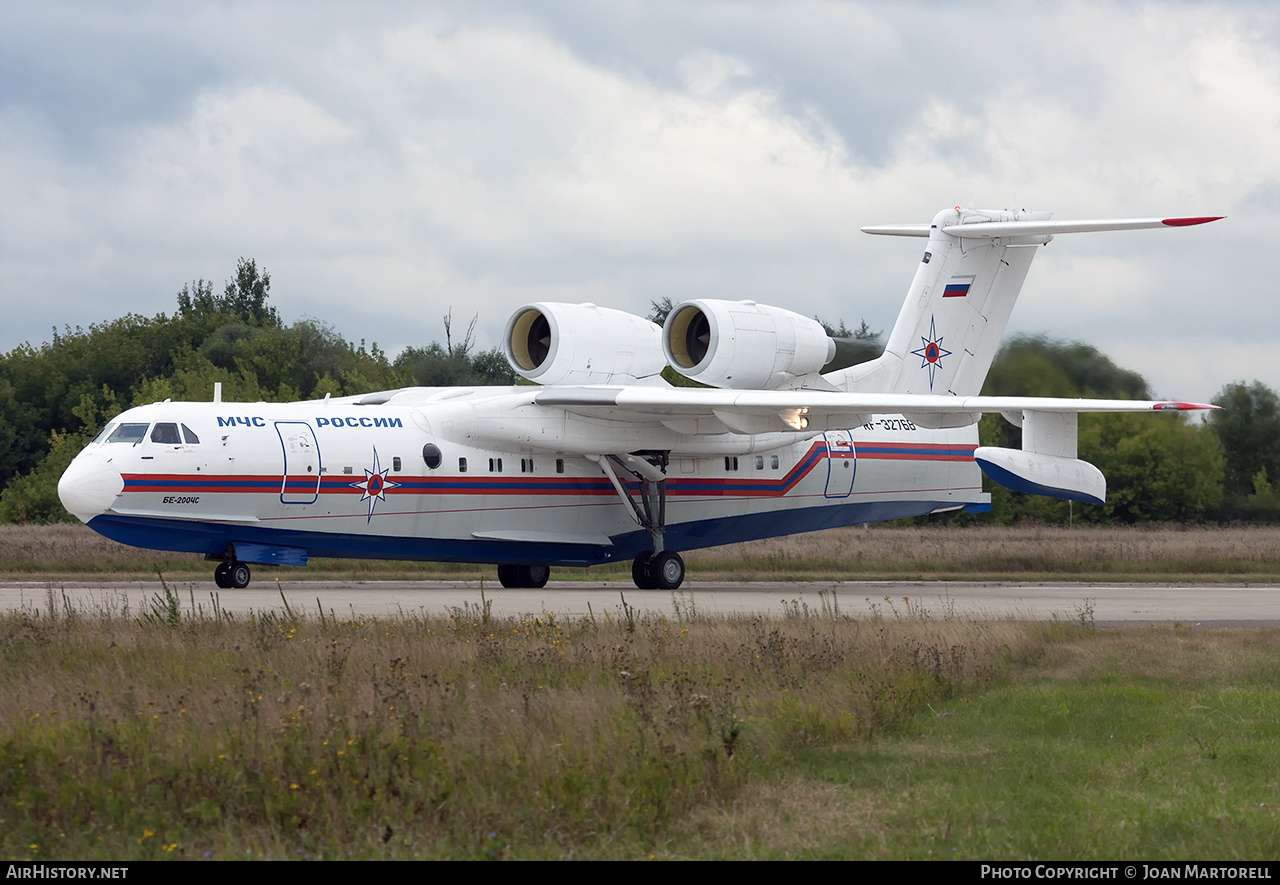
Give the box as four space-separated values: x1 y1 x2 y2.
0 525 1280 583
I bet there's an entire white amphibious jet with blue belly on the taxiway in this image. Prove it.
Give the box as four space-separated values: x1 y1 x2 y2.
58 207 1216 589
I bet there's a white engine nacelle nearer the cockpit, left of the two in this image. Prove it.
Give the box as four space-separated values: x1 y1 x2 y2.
502 302 667 384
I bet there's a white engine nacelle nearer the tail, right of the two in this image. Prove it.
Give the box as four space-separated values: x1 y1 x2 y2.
662 298 836 391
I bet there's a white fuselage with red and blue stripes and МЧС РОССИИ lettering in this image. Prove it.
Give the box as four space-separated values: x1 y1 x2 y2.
59 387 989 566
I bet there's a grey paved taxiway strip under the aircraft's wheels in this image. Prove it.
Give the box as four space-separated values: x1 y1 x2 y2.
0 580 1280 628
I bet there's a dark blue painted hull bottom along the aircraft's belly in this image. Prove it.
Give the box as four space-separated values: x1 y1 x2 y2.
88 501 991 566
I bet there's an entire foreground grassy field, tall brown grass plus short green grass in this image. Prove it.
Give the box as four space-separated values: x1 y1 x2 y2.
0 596 1280 859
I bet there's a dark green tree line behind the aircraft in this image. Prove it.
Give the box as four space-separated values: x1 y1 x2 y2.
0 259 1280 523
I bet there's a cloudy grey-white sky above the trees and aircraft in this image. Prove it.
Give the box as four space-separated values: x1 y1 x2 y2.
0 0 1280 400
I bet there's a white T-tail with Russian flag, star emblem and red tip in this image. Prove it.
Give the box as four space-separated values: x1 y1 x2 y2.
824 206 1221 396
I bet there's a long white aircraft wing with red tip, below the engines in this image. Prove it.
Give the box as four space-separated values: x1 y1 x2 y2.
534 387 1217 433
